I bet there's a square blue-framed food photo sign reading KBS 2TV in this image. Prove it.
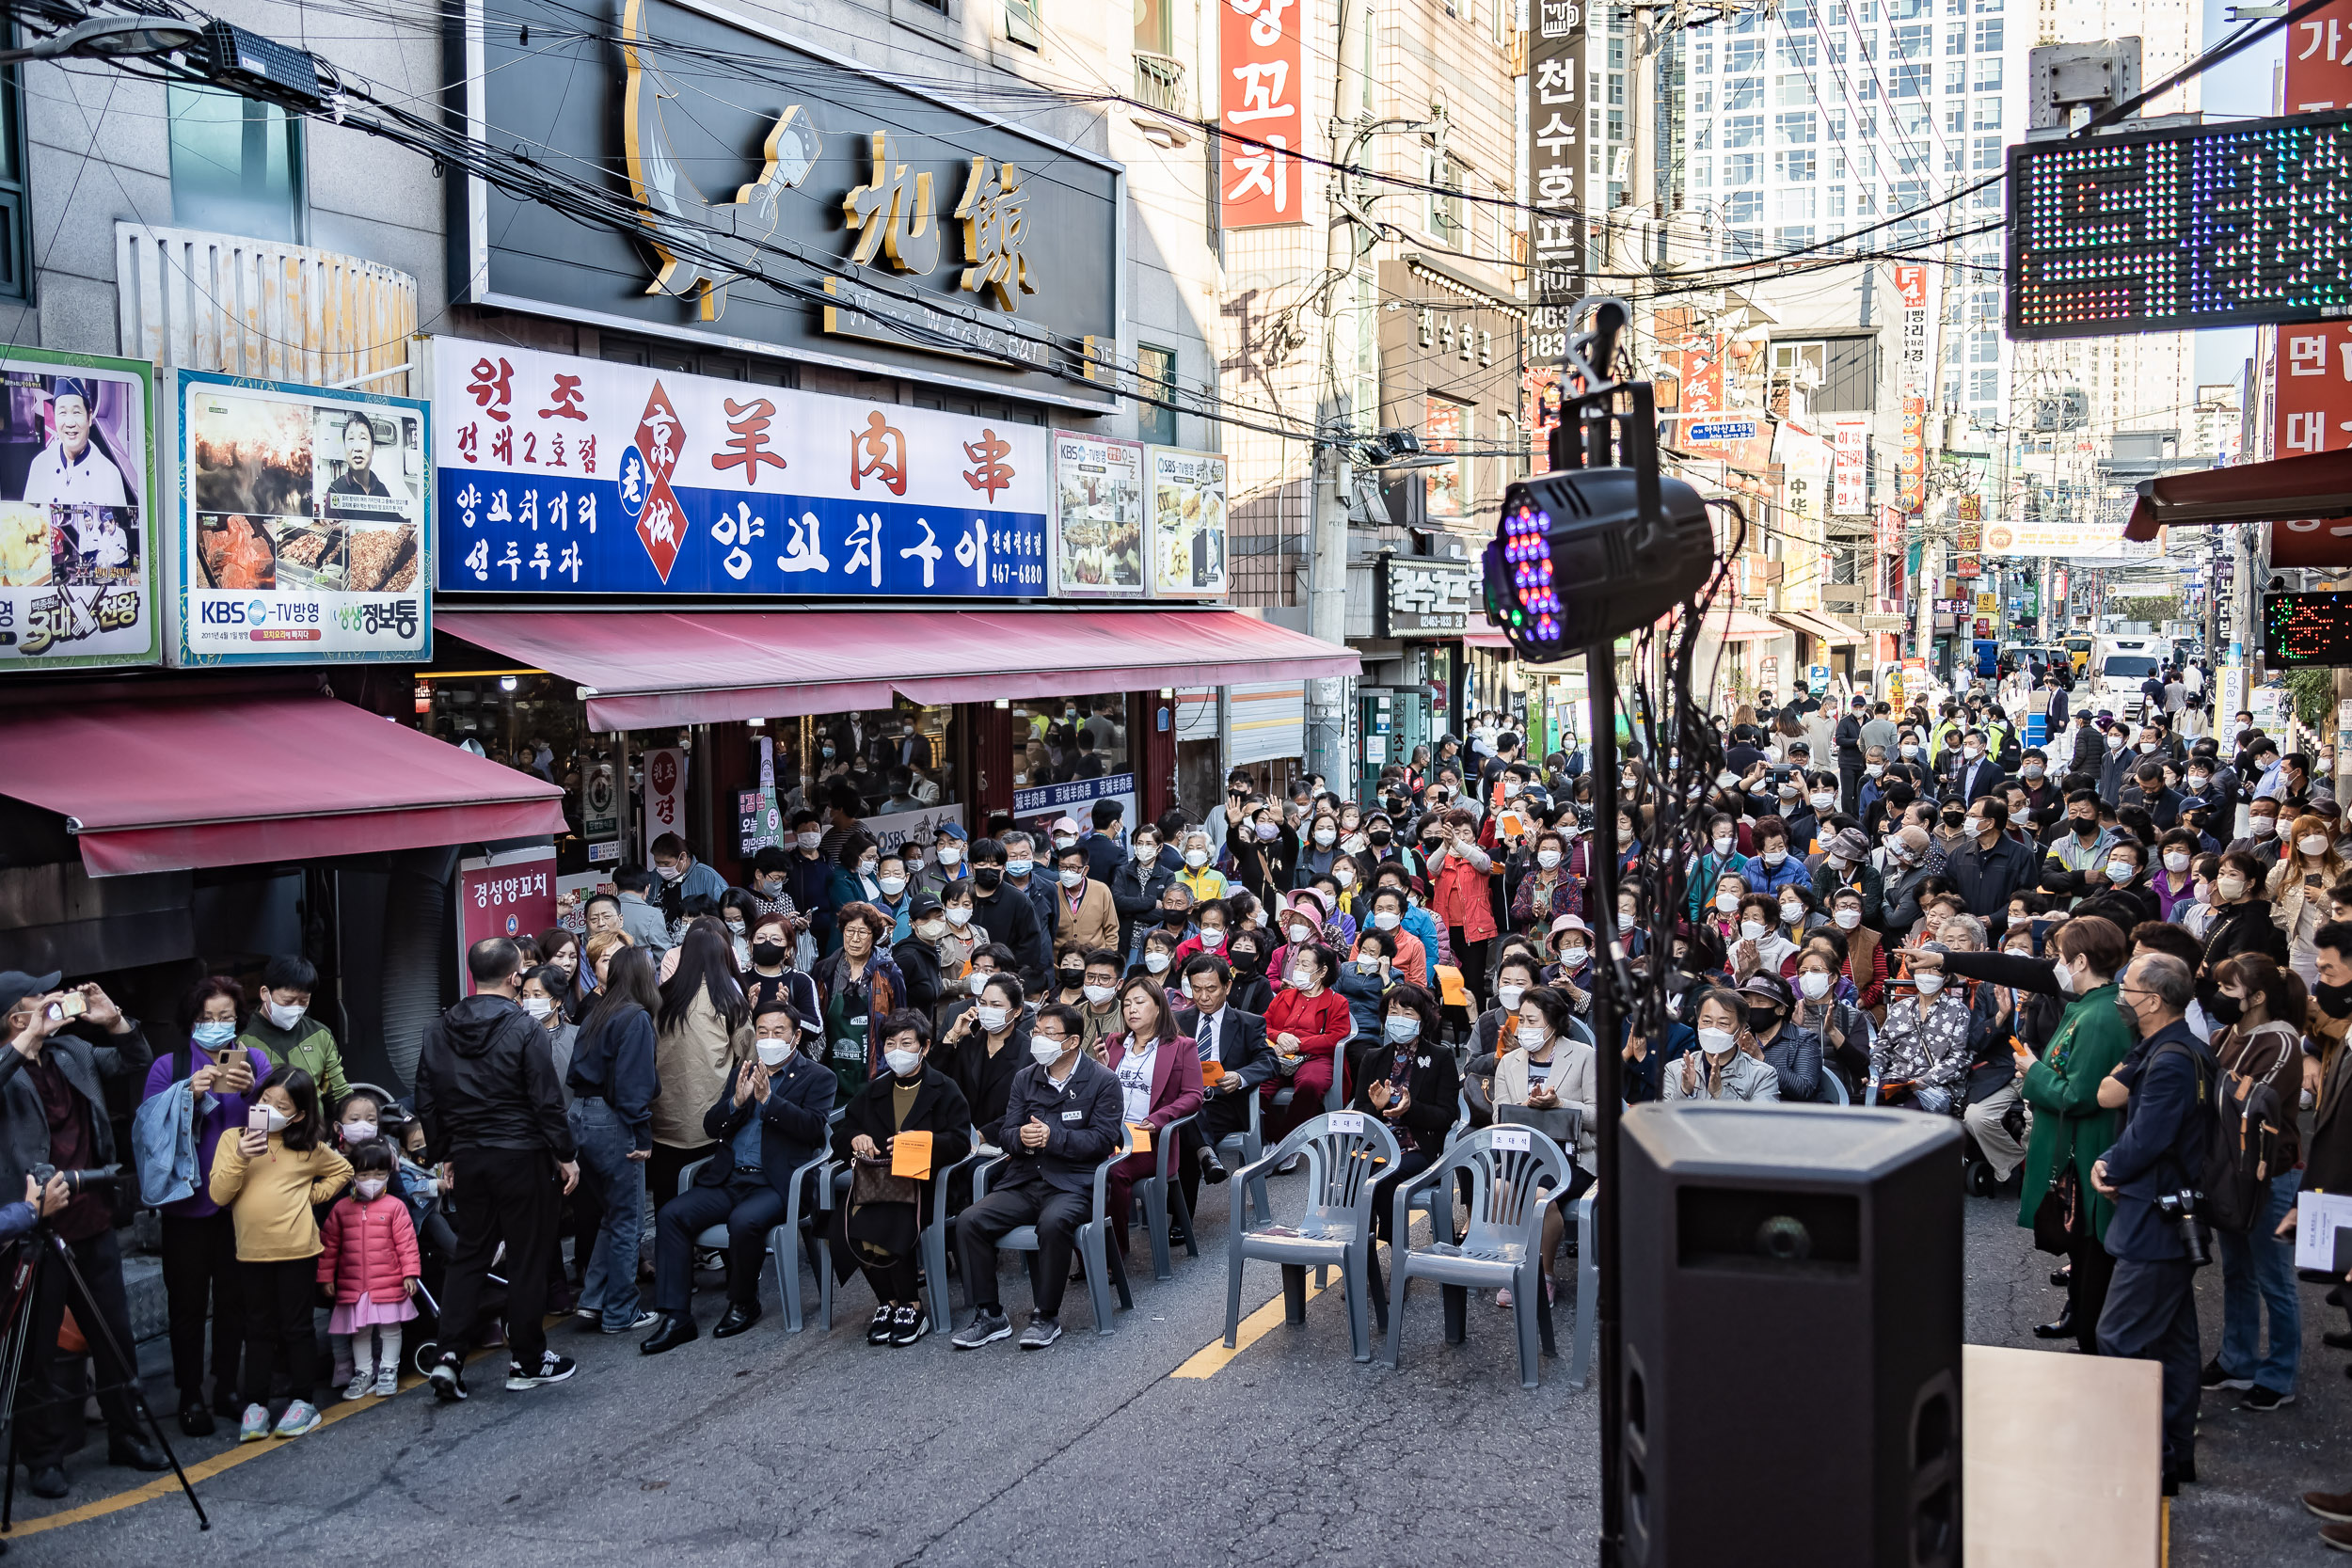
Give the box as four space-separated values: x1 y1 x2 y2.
174 372 433 665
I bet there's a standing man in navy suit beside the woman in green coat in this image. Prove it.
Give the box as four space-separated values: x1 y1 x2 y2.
2091 952 2216 1497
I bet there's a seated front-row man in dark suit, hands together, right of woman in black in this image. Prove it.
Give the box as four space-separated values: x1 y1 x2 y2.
948 1020 1124 1350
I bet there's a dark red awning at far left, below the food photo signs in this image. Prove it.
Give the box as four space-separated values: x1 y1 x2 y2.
0 696 564 877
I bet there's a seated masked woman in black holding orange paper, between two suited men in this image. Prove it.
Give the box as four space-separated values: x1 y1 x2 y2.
833 1020 974 1350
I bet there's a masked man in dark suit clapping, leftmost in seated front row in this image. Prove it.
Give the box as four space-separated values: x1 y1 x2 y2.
638 1001 837 1356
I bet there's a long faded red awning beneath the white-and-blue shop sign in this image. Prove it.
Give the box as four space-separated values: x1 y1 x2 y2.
436 609 1359 729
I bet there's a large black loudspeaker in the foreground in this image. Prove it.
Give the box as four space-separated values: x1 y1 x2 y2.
1618 1105 1962 1568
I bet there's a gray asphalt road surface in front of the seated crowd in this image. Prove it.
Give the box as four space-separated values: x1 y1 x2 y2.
9 1182 2352 1568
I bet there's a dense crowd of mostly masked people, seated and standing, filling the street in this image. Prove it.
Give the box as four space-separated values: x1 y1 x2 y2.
0 668 2352 1528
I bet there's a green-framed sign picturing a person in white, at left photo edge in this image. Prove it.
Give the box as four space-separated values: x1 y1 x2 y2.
0 348 155 673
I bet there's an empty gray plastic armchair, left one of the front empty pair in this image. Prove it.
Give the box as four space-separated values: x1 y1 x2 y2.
1226 1112 1400 1361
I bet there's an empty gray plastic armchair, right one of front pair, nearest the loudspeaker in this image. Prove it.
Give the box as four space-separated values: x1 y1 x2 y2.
1386 1126 1569 1389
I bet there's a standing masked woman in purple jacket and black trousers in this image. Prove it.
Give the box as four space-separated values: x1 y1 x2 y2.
141 975 271 1436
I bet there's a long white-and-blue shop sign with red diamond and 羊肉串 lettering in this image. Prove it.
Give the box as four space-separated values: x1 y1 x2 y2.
433 339 1052 599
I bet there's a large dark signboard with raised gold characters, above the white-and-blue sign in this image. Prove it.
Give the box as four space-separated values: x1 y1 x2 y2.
450 0 1129 411
